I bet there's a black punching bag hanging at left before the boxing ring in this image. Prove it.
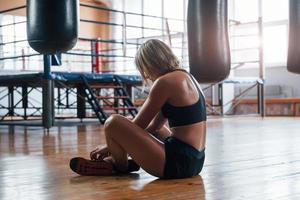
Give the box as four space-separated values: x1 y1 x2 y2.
27 0 79 54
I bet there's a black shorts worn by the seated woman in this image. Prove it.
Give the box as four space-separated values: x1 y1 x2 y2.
163 137 205 179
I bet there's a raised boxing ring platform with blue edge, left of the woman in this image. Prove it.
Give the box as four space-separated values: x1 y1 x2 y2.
0 72 142 124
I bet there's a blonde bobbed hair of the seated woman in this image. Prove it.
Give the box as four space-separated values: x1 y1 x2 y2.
135 39 180 80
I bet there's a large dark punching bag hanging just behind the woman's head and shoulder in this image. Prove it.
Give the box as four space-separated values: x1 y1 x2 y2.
187 0 230 83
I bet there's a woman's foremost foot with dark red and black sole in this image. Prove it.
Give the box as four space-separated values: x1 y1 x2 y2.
70 157 115 176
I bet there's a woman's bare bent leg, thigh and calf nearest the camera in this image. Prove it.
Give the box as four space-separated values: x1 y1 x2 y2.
104 115 165 177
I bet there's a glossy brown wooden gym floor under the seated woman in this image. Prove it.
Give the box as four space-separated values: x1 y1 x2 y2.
0 117 300 200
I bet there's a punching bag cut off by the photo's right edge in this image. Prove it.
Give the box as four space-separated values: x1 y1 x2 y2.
287 0 300 74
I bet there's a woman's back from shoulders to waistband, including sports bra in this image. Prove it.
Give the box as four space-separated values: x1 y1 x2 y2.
157 70 206 150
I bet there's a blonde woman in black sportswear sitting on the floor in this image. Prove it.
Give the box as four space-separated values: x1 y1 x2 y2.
70 39 206 178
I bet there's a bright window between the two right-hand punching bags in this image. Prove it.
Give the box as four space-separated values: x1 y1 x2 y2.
230 0 288 67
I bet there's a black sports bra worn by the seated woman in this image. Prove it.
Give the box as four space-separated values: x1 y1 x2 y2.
161 69 206 127
